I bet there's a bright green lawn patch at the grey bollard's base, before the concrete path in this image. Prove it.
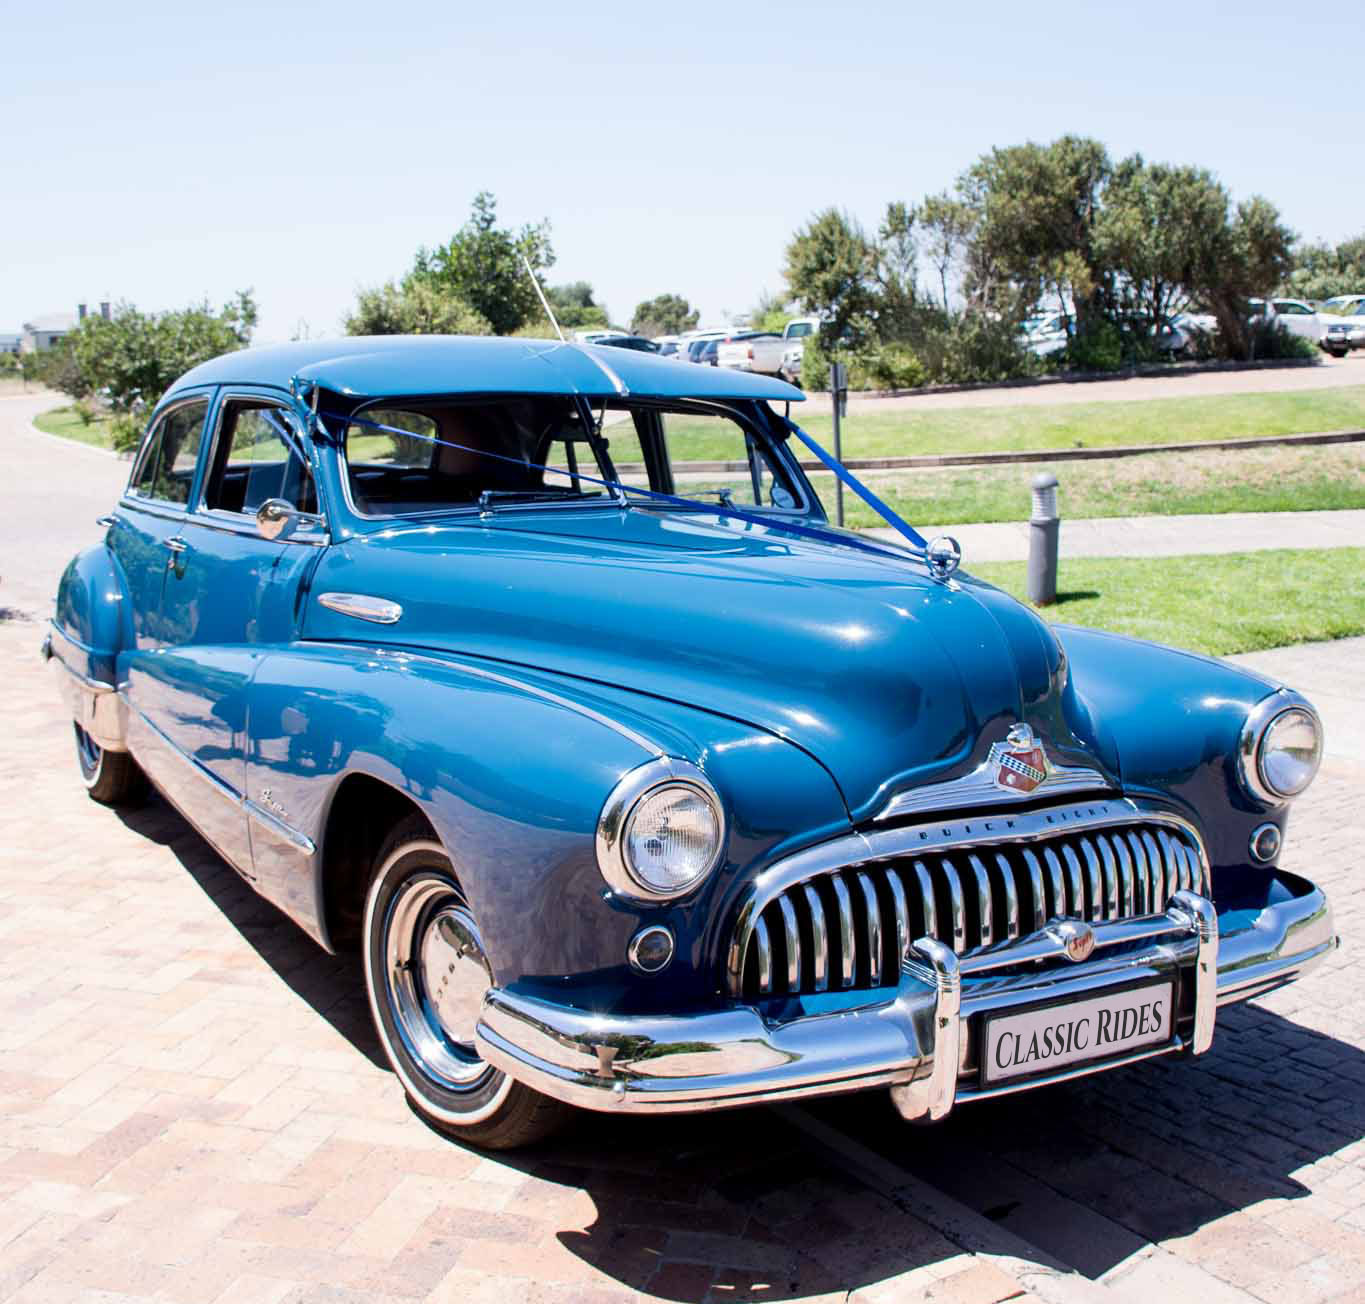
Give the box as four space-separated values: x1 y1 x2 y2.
972 548 1365 655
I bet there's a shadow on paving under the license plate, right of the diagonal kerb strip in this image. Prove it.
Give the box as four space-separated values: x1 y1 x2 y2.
820 1004 1365 1278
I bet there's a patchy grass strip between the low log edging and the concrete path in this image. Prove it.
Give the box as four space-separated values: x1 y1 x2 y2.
813 442 1365 528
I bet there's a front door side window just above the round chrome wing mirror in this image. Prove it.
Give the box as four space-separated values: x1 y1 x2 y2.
205 399 318 515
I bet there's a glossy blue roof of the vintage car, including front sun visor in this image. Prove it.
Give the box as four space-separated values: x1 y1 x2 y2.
167 335 805 403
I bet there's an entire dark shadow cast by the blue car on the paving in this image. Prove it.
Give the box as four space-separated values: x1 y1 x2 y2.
119 796 1365 1301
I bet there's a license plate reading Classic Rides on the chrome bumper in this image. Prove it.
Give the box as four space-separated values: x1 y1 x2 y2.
981 983 1175 1084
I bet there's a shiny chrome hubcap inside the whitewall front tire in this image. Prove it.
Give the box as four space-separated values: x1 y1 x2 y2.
384 871 493 1091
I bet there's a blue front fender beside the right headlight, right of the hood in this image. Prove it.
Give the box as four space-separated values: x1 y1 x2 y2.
1057 625 1284 866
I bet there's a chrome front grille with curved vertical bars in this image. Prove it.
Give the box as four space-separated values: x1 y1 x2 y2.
730 818 1209 1001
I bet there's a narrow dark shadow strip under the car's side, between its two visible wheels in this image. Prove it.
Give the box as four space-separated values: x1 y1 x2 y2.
116 792 388 1069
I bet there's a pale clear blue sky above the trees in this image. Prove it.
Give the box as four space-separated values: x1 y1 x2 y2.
0 0 1365 343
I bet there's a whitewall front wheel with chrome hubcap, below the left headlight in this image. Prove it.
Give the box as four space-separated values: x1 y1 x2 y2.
363 815 568 1150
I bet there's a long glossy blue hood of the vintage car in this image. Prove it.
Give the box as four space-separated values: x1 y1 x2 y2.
304 509 1117 819
